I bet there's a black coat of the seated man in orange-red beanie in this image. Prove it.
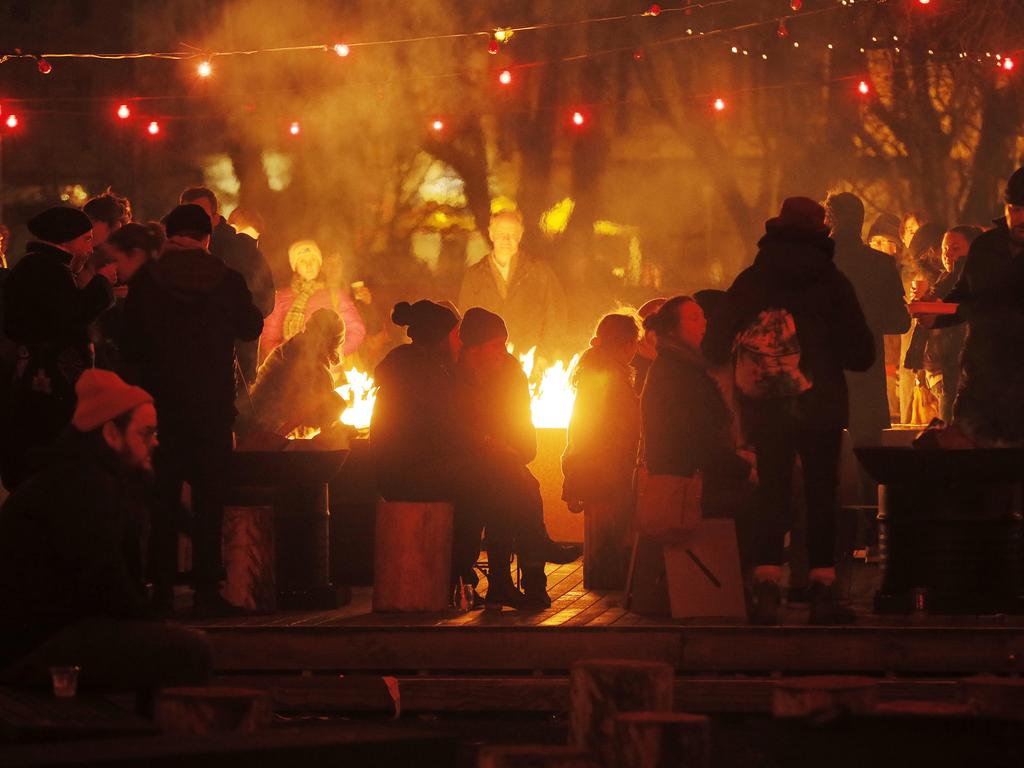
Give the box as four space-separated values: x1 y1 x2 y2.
0 429 150 667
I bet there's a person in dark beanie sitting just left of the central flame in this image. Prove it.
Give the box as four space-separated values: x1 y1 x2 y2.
457 307 580 608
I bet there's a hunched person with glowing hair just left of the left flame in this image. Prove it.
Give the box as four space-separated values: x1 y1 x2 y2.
246 309 345 436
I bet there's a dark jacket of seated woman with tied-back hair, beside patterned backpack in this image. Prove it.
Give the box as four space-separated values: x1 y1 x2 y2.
640 339 751 488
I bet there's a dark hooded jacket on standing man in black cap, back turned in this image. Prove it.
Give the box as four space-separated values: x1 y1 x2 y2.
123 241 263 421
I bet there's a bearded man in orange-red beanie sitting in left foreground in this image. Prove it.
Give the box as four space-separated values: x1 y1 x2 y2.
0 371 210 691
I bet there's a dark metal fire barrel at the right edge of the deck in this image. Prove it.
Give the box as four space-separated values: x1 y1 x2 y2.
856 447 1024 613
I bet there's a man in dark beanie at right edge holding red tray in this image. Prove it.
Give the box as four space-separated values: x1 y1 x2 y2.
922 168 1024 445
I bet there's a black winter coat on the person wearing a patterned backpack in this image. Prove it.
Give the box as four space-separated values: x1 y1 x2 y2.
703 226 876 436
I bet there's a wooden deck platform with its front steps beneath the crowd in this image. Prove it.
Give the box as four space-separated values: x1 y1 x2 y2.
196 562 1024 712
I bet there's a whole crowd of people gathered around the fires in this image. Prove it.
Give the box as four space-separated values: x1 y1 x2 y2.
0 160 1024 687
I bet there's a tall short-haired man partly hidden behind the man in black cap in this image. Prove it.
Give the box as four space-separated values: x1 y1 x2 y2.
178 186 274 385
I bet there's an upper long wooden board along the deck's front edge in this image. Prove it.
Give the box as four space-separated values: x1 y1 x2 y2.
201 626 1024 674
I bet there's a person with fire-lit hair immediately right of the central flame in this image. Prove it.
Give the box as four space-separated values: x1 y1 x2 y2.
562 314 641 589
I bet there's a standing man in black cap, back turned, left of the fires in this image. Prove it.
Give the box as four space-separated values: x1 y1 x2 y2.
123 205 263 614
